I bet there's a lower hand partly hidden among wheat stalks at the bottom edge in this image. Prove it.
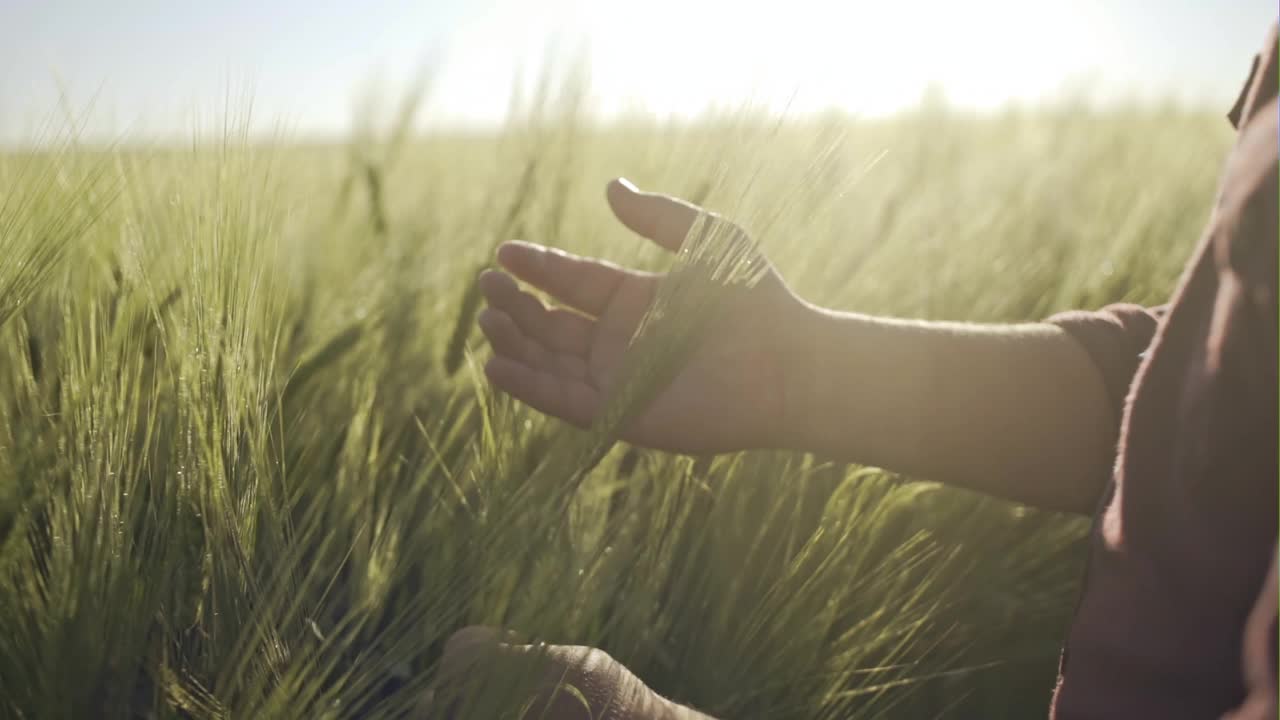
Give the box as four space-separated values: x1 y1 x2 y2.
430 626 712 720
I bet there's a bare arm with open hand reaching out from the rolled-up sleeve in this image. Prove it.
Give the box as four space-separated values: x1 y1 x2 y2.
480 182 1117 512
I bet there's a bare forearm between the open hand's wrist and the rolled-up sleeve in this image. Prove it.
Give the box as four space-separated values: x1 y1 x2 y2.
780 302 1117 511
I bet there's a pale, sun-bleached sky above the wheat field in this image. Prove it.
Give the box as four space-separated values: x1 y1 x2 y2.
0 0 1276 142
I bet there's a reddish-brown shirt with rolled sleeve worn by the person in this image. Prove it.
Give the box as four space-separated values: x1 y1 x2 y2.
1052 26 1280 720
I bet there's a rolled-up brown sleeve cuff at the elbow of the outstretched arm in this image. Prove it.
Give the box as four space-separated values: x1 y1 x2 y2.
1048 302 1165 423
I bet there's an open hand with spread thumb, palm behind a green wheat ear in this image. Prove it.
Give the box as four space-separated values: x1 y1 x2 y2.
479 179 806 454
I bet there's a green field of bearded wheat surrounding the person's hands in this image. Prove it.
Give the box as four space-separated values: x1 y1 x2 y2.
0 87 1231 720
